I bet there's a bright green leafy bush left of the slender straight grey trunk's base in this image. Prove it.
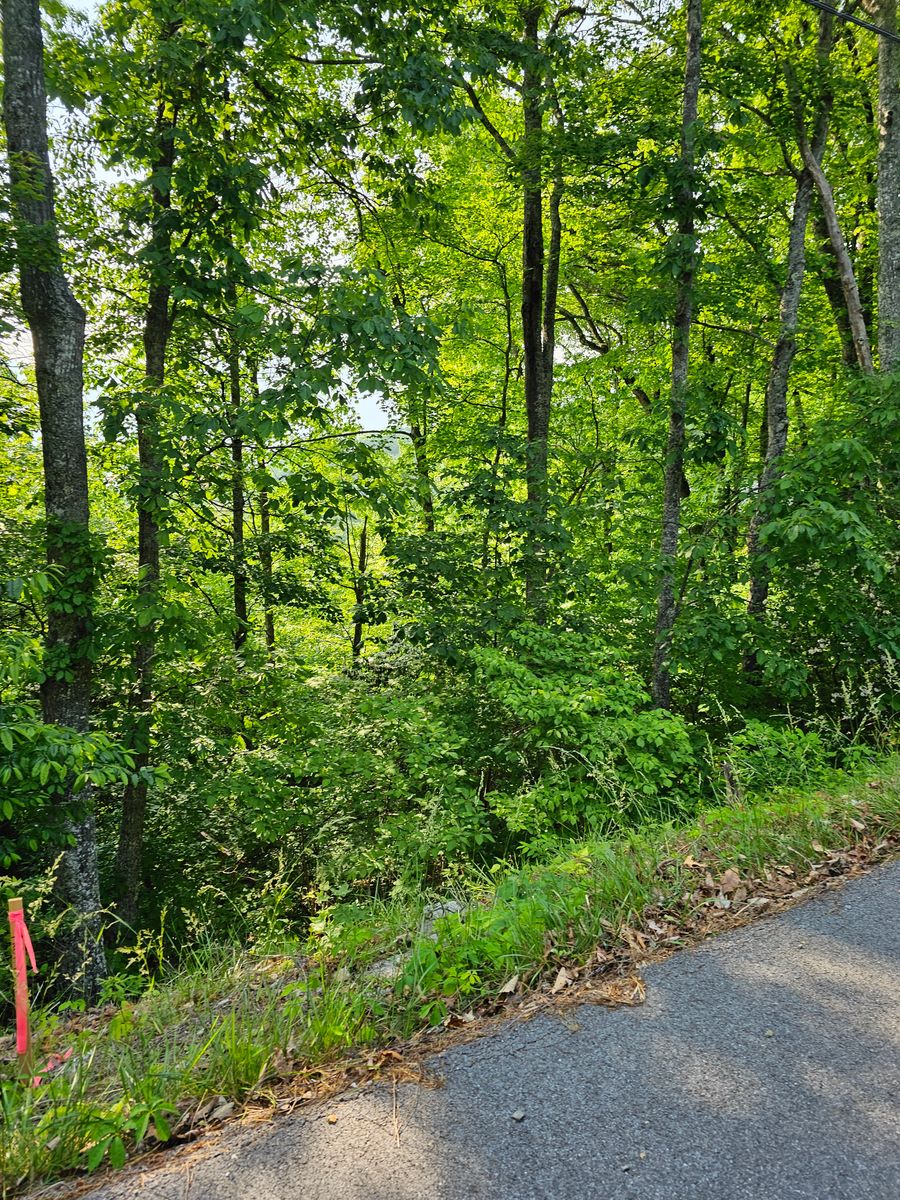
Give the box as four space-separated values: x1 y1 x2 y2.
472 628 701 836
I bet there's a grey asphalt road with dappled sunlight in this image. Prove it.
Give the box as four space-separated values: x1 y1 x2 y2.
91 863 900 1200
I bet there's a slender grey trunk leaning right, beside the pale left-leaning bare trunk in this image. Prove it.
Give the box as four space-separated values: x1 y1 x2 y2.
744 13 834 652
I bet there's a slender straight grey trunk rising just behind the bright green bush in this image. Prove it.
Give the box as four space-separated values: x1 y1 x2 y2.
653 0 703 708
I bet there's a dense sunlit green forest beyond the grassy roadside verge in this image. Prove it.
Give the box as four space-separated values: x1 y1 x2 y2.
0 0 900 1171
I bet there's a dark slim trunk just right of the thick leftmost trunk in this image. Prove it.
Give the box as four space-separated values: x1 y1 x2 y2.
115 126 175 926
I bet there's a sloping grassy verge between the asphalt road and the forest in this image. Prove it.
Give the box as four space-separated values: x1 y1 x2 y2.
0 756 900 1198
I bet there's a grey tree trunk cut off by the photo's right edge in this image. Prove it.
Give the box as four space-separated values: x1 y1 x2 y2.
877 0 900 371
